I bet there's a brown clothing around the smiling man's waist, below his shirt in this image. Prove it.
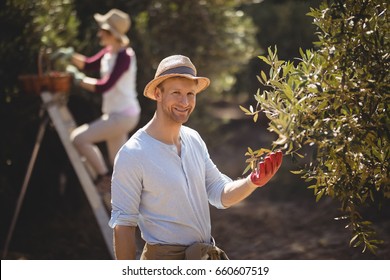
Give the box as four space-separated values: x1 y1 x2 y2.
141 243 229 260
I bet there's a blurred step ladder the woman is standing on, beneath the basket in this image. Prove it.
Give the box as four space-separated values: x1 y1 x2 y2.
3 91 114 259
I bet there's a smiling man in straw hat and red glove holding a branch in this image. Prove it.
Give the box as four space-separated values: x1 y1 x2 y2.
109 55 282 259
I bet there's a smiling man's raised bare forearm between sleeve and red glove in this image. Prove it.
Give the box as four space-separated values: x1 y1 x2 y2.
222 178 257 207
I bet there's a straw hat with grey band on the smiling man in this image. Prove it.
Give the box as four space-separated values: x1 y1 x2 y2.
144 55 210 100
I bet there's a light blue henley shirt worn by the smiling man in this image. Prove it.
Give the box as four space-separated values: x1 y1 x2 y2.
109 126 231 245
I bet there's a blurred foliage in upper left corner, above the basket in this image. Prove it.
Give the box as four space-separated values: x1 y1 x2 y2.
0 0 78 95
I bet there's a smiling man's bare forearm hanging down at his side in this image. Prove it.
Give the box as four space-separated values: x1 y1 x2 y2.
114 226 136 260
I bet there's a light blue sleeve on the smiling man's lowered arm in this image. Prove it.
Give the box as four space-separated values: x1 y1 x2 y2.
109 146 142 228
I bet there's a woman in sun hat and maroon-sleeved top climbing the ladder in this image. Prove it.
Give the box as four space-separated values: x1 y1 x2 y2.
52 9 141 210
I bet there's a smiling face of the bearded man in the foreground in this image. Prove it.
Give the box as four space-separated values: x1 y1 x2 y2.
156 78 197 124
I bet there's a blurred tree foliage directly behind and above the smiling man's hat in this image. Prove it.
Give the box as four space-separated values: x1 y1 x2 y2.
135 0 256 96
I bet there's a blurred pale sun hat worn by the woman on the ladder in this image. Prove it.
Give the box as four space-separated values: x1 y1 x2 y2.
93 9 131 45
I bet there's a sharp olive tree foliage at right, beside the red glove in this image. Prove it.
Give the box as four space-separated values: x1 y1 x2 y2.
242 0 390 253
